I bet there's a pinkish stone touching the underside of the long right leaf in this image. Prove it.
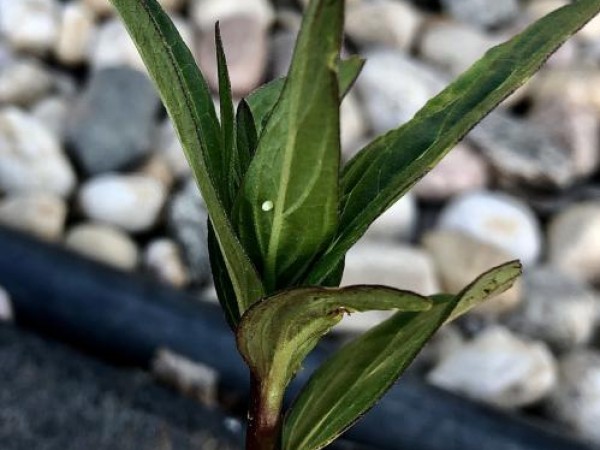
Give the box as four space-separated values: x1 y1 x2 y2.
412 142 491 201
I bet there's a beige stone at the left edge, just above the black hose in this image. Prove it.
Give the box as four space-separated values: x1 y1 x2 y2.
0 192 67 241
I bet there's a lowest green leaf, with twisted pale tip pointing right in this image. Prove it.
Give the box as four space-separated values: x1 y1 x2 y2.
283 261 521 450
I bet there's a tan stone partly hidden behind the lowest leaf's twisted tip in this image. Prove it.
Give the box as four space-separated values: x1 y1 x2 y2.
423 230 522 317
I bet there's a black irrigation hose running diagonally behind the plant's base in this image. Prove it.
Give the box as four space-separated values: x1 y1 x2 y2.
0 229 593 450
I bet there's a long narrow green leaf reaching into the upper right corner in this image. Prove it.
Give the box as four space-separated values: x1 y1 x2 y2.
306 0 600 284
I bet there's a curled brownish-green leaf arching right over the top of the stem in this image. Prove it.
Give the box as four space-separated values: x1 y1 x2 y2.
237 286 431 416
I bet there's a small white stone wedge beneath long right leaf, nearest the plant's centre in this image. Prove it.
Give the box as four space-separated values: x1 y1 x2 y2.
364 193 418 242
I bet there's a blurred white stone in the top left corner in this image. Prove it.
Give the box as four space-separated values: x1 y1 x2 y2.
0 0 59 53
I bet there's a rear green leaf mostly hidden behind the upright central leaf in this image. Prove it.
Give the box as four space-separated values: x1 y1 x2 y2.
247 55 365 135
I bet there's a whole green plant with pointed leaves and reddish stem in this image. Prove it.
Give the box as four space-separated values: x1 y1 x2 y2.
111 0 600 450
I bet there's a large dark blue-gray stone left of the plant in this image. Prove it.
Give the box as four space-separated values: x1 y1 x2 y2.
67 67 159 174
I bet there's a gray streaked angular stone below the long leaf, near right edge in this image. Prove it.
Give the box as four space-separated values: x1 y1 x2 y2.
470 112 575 188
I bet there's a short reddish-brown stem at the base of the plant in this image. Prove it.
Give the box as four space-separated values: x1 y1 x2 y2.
246 376 283 450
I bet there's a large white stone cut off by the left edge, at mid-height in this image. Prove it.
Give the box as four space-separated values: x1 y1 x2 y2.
0 108 76 197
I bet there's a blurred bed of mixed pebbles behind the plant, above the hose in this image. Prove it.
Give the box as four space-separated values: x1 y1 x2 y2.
0 0 600 445
